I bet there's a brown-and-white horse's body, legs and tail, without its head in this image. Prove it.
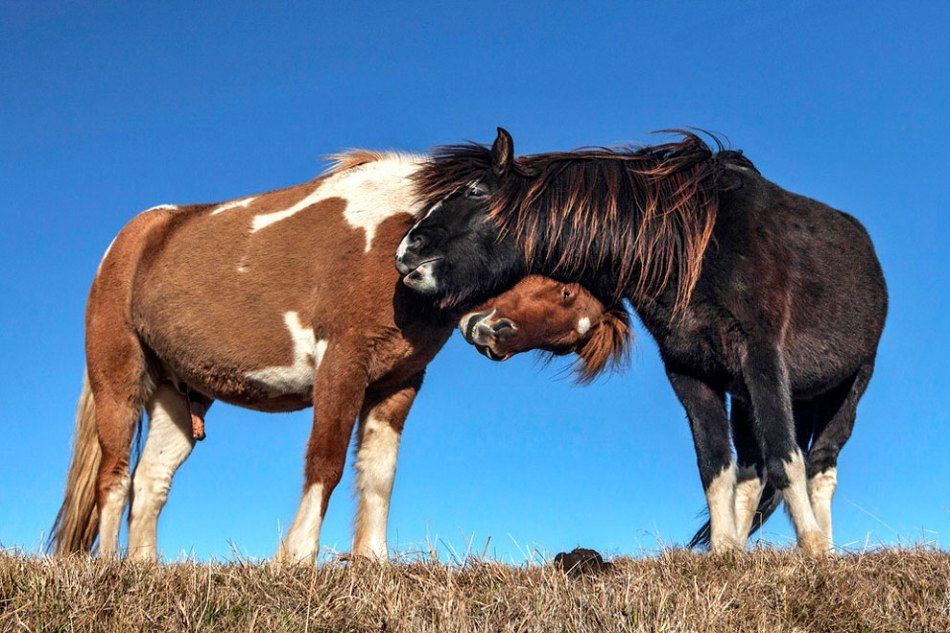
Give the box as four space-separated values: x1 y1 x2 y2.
50 151 556 561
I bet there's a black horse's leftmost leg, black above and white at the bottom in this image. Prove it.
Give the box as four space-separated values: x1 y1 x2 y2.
666 366 739 552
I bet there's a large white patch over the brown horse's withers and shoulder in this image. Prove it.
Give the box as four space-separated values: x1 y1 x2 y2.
251 154 420 252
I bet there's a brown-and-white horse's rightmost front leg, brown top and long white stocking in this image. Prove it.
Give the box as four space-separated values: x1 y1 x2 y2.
353 372 423 560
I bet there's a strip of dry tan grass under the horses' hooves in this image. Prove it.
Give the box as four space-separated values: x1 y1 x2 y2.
0 548 950 633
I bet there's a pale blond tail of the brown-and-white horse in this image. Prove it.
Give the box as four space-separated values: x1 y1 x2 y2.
46 371 102 554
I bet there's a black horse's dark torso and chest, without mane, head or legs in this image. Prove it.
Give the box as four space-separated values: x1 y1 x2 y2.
643 167 887 395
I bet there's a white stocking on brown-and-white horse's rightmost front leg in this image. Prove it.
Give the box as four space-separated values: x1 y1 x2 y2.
353 412 400 560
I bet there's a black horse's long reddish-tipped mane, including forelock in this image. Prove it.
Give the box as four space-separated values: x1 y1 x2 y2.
417 130 755 314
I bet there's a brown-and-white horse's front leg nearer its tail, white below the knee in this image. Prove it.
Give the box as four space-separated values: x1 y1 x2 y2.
277 341 368 563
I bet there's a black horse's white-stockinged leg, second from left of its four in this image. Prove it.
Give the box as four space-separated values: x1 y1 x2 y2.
729 397 765 549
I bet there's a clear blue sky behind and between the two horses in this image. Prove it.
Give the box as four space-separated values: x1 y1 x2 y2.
0 0 950 560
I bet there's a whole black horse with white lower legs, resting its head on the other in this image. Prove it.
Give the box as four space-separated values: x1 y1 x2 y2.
397 129 887 554
